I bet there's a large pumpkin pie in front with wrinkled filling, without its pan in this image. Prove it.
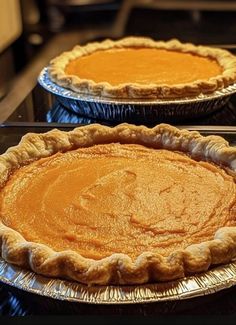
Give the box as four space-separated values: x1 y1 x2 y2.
0 124 236 285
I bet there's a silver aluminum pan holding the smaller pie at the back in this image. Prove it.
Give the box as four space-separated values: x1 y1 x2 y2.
38 67 236 123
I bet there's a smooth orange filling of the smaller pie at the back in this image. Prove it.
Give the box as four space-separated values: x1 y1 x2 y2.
65 48 222 86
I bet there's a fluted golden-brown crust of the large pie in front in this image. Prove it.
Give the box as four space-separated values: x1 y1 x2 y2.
0 124 236 285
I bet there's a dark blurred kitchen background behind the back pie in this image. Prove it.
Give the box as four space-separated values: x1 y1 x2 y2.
0 0 236 96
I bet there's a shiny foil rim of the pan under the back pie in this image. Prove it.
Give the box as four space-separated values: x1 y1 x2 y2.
38 67 236 105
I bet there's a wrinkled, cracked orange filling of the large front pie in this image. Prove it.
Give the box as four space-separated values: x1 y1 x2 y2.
0 143 236 259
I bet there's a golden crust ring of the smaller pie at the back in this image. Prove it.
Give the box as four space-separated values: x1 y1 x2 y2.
48 37 236 99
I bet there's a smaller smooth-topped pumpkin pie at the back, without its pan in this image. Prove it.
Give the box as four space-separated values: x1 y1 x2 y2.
48 37 236 100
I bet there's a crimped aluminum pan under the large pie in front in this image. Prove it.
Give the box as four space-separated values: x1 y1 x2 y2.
0 258 236 305
